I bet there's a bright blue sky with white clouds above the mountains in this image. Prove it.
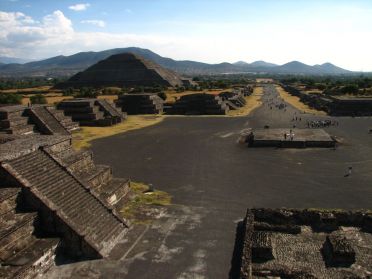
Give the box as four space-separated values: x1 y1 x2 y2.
0 0 372 71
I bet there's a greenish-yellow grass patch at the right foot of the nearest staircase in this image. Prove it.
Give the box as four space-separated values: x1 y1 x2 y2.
120 182 172 224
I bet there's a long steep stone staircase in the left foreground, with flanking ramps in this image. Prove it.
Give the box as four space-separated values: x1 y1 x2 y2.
2 150 127 257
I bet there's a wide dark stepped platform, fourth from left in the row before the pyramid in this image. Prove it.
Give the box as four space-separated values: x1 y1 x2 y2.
169 93 229 115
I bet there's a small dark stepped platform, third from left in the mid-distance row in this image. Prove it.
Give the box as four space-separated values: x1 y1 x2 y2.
116 93 164 114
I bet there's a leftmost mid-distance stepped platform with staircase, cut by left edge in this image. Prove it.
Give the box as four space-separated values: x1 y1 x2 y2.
0 105 79 135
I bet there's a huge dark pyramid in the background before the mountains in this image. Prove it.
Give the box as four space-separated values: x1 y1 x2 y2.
57 53 182 88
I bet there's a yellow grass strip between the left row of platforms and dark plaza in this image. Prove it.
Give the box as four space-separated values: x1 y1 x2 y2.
72 115 164 150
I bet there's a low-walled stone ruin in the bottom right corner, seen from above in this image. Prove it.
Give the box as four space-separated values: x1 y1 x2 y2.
240 209 372 279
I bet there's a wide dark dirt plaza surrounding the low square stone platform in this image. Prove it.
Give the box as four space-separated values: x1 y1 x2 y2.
50 85 372 278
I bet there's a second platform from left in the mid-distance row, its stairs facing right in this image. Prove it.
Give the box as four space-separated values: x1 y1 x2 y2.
57 99 126 126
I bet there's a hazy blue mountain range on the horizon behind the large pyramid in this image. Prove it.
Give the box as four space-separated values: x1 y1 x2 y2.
0 47 354 77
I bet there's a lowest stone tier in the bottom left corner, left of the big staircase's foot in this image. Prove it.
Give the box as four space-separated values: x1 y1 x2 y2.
0 238 59 279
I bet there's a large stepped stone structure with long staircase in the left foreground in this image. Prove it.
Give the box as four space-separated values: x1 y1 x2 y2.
0 135 131 278
